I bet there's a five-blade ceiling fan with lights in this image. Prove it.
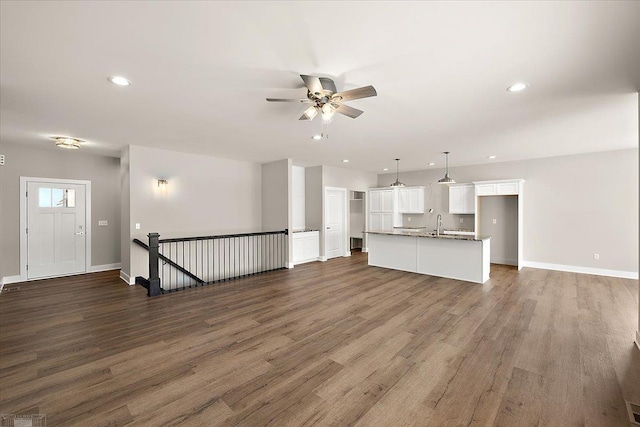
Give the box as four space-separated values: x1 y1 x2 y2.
267 74 378 123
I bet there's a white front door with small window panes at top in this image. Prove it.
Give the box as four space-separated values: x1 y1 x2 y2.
26 181 87 279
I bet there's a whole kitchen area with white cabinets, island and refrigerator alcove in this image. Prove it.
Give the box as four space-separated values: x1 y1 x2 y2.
366 179 524 283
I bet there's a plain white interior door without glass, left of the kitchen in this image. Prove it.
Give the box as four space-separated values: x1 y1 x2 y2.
324 187 347 259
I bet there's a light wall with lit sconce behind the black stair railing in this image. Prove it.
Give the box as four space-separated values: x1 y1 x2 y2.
124 145 262 277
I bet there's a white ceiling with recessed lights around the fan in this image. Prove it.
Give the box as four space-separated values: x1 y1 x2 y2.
0 1 640 172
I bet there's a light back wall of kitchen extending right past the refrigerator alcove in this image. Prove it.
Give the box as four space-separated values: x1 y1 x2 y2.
378 149 638 274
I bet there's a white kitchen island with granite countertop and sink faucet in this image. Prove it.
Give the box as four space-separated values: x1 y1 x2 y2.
365 230 491 283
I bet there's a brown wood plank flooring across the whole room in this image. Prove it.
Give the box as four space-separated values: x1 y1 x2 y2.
0 253 640 427
